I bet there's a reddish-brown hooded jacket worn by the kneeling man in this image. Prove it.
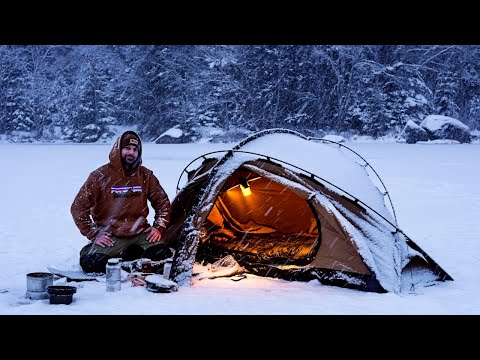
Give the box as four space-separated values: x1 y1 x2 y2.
70 133 170 241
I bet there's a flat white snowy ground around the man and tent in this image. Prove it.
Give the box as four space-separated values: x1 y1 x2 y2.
0 142 480 315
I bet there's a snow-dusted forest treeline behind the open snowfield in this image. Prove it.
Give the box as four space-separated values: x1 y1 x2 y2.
0 45 480 142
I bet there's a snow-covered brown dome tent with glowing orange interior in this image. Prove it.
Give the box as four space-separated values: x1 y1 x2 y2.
165 129 452 293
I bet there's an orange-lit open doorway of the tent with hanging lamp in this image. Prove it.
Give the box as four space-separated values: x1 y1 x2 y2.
196 170 321 268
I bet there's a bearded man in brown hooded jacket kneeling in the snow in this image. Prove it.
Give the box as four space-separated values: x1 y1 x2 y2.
71 131 173 273
